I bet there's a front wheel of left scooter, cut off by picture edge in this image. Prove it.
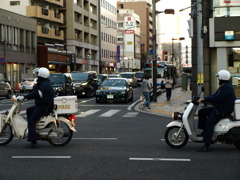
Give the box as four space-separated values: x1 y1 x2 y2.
0 123 13 146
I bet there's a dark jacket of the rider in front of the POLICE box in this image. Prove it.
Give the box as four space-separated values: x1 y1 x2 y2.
25 78 55 108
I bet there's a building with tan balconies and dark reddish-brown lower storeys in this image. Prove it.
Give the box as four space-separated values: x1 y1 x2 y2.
1 0 66 72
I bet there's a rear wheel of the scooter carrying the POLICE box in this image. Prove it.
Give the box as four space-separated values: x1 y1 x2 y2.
48 121 73 146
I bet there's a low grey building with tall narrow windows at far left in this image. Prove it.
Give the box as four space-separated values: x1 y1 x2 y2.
0 9 37 89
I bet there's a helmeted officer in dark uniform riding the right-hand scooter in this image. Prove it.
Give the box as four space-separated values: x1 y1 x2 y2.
198 70 236 152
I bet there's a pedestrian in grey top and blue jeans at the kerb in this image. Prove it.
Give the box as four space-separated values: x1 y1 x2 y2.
142 76 152 109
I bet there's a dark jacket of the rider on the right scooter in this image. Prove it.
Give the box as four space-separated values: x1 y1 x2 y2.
204 82 236 115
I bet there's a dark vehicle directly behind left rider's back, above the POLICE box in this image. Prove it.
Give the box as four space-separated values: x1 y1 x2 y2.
48 73 74 96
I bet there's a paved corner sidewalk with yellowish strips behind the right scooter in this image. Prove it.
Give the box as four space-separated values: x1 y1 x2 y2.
136 87 192 117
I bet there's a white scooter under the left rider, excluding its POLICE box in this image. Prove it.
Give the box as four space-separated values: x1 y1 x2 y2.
0 95 76 146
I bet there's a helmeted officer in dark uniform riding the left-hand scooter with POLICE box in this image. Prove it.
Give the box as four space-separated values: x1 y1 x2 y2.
24 67 55 148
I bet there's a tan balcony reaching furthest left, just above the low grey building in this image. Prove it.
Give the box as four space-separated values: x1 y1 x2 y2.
26 6 50 20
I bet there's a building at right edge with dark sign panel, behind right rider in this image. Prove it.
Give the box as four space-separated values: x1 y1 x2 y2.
192 0 240 98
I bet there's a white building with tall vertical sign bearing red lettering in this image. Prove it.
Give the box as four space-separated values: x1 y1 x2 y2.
117 9 141 72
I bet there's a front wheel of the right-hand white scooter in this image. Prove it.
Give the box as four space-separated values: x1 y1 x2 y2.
165 126 189 149
